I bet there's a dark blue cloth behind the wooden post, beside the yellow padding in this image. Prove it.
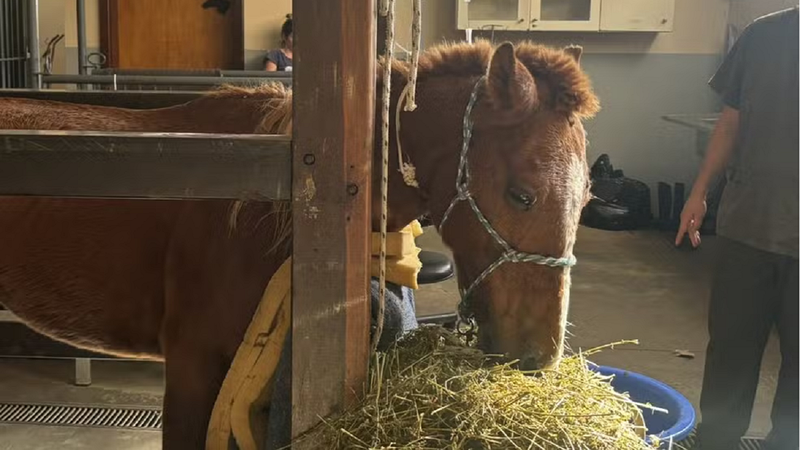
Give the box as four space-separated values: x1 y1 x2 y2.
265 279 419 450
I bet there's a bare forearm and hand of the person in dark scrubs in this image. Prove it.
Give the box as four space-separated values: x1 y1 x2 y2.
675 106 739 247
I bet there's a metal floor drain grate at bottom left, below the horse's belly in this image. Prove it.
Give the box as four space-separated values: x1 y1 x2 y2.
0 403 161 430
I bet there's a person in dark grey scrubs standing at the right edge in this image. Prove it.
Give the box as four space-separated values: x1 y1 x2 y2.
675 7 800 450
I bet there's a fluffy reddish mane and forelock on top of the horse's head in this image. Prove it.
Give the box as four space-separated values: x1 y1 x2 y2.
388 40 600 118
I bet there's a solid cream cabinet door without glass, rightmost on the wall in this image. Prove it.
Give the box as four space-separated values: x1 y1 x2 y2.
600 0 675 31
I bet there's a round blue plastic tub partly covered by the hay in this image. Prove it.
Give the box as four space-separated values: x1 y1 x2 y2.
591 366 697 448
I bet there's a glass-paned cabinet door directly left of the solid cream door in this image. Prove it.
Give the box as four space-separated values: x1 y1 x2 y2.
530 0 605 31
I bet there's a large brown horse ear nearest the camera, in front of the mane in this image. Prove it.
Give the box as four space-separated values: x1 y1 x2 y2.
486 42 536 113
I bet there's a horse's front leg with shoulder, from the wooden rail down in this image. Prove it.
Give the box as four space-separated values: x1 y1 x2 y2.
161 202 285 450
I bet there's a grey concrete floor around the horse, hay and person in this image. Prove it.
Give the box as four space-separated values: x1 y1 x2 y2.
0 228 780 450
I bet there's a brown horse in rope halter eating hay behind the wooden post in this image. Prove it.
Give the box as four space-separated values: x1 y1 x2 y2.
0 42 598 449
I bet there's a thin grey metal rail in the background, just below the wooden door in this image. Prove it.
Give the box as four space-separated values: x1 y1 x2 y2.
42 72 292 86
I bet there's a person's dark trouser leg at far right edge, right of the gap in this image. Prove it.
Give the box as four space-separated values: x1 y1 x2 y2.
764 255 800 450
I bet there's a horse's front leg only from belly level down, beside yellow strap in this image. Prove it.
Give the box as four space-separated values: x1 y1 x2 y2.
162 340 230 450
